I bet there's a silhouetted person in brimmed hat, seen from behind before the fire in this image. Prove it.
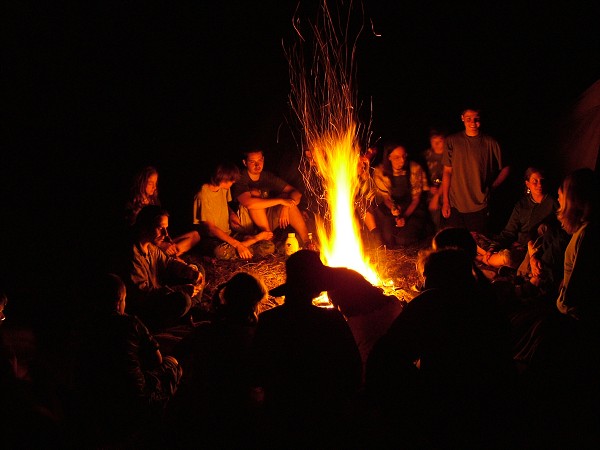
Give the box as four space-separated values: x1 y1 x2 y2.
253 250 362 447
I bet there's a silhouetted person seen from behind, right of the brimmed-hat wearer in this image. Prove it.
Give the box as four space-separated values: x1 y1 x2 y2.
366 249 516 448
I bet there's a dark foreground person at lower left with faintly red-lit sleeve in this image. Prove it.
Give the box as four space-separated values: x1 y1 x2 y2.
74 274 182 445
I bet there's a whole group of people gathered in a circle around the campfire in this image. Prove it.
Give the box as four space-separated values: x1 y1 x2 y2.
0 109 600 448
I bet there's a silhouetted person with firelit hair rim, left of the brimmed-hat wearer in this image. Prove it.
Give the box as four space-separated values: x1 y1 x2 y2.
164 272 268 448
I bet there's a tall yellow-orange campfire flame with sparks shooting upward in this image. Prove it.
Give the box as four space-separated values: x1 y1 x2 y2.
287 1 382 284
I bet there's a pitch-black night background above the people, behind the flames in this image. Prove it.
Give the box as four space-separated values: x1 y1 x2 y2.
0 0 600 318
